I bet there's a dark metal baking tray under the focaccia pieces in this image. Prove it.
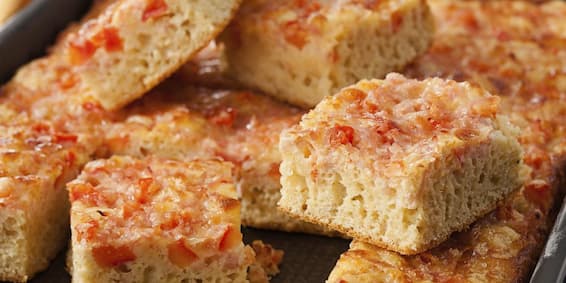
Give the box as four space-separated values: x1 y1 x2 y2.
0 0 566 283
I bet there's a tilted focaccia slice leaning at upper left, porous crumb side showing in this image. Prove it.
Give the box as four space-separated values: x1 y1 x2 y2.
11 0 241 110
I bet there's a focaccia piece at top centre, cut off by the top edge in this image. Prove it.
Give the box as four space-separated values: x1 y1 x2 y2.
221 0 433 107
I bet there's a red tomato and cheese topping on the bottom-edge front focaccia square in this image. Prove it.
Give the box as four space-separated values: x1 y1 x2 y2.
68 156 242 265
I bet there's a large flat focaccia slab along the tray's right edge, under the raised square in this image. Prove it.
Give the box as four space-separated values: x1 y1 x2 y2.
328 1 566 283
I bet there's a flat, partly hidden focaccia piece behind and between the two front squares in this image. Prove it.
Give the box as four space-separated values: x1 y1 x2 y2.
103 81 338 236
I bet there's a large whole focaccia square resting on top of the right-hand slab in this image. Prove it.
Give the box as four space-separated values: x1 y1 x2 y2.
279 74 525 254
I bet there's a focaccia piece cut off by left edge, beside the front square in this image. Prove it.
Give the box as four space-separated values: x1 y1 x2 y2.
0 121 93 281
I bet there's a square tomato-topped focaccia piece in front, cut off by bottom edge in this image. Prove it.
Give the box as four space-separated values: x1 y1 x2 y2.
68 156 254 282
